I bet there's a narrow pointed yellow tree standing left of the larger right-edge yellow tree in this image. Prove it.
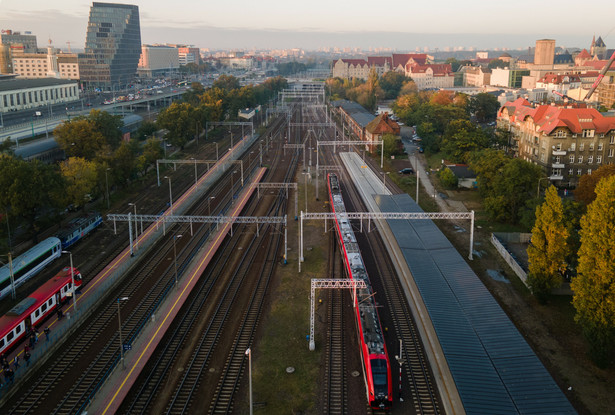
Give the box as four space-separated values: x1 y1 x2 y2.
527 186 570 302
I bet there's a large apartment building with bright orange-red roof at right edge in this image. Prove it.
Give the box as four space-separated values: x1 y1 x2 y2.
498 98 615 187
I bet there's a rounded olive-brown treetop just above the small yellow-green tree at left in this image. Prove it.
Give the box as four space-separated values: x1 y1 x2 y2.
53 118 109 160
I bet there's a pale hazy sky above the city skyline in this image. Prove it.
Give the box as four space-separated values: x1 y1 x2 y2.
0 0 615 50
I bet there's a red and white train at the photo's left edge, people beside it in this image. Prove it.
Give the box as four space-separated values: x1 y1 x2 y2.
0 267 82 353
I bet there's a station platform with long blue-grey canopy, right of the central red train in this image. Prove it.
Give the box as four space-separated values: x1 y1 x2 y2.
341 153 576 414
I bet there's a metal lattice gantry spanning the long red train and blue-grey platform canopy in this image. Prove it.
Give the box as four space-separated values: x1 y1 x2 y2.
299 211 474 272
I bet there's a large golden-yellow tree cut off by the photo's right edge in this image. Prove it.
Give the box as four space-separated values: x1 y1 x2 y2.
571 176 615 366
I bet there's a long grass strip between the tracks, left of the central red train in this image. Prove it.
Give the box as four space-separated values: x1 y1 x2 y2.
247 177 328 414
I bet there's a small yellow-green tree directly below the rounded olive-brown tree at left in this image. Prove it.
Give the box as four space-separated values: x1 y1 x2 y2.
60 157 98 211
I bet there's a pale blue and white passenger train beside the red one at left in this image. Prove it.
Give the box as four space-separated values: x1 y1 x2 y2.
0 237 62 298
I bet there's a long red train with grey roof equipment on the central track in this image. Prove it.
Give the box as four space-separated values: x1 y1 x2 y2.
327 174 393 410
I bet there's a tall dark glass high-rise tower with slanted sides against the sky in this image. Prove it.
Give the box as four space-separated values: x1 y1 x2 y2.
79 3 141 89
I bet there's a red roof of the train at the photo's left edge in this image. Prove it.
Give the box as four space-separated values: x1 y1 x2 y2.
0 267 79 338
